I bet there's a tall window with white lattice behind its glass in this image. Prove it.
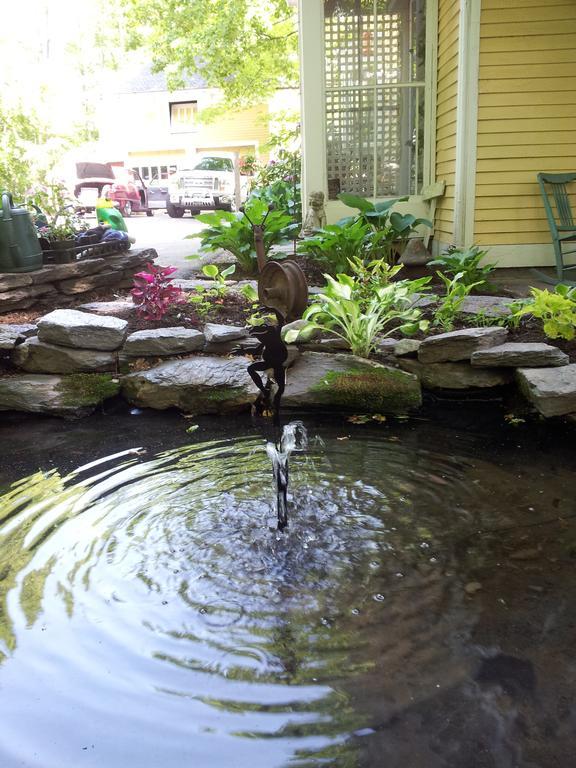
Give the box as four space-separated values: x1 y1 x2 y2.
324 0 425 200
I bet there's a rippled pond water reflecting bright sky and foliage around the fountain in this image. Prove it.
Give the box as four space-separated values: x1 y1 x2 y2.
0 414 573 768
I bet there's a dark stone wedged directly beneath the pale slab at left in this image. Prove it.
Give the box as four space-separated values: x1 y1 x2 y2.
12 337 117 373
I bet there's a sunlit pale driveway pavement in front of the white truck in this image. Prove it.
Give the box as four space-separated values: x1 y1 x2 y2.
126 210 212 278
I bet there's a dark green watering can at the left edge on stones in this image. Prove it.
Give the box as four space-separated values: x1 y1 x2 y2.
0 192 42 273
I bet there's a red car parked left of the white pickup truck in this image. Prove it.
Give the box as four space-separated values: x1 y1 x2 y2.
74 163 153 216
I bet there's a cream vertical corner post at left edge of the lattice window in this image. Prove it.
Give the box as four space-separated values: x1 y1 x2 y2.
298 0 328 204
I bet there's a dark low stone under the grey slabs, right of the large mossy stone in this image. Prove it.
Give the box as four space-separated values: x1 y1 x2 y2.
398 357 512 390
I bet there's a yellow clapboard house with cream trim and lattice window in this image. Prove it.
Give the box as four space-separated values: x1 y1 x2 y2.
300 0 576 266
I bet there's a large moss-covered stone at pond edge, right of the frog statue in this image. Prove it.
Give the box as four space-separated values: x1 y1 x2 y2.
282 352 422 413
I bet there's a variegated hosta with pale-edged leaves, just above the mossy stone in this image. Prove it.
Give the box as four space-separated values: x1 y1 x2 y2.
286 274 430 357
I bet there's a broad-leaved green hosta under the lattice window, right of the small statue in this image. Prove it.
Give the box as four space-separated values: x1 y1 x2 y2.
338 192 432 264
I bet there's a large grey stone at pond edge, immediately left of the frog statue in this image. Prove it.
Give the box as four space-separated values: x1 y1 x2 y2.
122 356 258 414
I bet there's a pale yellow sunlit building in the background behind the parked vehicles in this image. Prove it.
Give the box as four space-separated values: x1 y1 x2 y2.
99 64 294 180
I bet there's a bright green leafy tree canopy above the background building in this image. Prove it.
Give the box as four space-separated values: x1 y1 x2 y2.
123 0 298 114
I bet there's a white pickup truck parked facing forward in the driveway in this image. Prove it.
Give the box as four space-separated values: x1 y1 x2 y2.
166 153 248 219
